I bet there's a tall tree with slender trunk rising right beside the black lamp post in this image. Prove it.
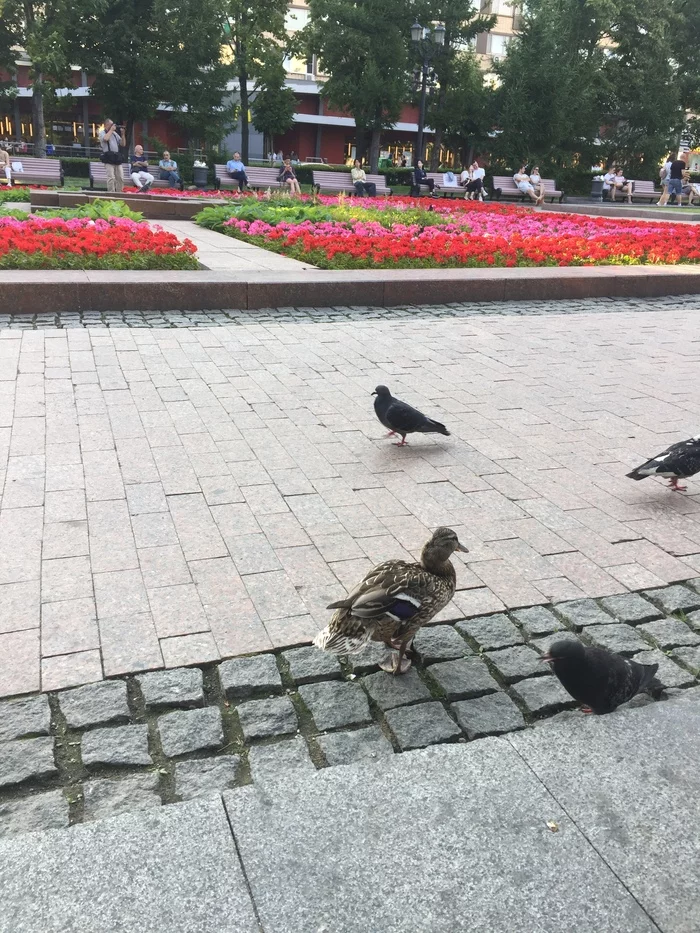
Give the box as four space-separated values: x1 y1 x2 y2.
419 0 496 171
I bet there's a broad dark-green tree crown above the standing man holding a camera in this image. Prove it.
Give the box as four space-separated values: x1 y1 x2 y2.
71 0 227 146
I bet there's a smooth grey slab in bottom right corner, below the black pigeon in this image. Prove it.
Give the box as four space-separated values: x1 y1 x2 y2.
504 695 700 933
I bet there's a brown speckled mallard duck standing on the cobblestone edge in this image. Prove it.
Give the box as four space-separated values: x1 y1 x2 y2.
313 528 468 674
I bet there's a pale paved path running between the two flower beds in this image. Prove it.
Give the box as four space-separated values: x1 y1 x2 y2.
157 220 316 272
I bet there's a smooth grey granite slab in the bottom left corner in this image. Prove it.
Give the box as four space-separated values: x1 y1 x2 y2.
0 799 260 933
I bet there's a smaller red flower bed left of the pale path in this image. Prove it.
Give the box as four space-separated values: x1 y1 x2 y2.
0 214 198 269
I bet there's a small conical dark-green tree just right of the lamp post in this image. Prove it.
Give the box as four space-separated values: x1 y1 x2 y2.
428 49 494 166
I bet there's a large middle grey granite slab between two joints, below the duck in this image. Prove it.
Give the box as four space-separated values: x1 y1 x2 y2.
224 739 667 933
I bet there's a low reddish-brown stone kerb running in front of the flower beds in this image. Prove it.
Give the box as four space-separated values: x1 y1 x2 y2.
0 265 700 314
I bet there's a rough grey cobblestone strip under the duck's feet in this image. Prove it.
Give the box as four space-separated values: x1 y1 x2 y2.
0 579 700 838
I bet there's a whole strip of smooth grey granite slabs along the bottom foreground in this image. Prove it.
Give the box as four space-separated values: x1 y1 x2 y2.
0 690 700 933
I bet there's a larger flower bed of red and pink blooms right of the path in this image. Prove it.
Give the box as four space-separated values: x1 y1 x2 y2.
197 196 700 269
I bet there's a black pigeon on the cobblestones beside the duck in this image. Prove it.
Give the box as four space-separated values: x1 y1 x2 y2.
542 638 659 715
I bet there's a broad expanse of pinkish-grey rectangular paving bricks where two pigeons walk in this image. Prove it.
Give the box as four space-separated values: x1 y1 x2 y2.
0 297 700 696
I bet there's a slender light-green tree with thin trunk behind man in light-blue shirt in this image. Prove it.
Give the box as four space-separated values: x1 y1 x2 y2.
223 0 288 162
